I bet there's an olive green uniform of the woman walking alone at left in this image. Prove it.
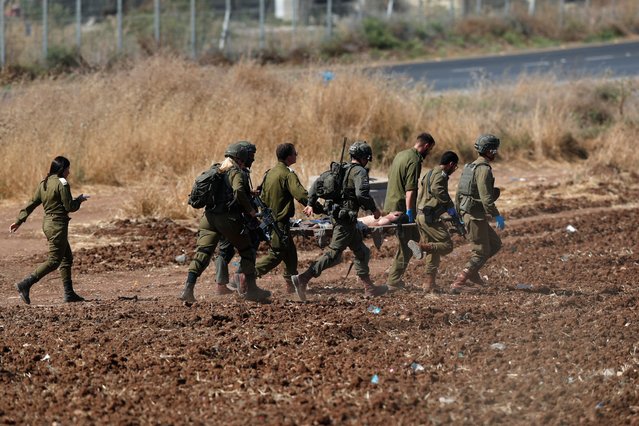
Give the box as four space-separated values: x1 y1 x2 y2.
16 175 81 285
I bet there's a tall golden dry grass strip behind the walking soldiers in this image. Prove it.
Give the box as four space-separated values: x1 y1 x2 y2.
0 57 639 218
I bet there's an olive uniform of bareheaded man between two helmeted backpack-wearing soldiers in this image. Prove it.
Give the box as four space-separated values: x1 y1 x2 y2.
256 161 308 280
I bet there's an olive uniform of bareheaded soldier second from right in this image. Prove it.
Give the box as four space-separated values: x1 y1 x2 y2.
417 167 454 274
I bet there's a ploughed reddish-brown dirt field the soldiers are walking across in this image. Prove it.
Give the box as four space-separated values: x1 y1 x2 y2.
0 164 639 425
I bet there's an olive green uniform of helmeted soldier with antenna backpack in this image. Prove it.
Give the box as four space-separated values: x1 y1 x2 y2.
310 163 377 277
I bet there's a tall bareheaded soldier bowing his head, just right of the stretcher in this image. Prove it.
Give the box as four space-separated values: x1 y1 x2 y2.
384 133 435 290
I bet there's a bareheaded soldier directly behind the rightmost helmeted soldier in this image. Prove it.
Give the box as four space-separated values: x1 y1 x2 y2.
408 151 459 291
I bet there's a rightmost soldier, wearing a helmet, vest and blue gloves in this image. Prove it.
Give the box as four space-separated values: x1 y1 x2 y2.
450 135 506 293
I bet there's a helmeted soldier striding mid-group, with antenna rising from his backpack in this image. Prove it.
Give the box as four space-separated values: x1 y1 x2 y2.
291 141 388 301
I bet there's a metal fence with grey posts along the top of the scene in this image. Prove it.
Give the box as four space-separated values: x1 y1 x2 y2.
0 0 632 67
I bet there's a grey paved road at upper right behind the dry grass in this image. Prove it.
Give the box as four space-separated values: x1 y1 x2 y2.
381 42 639 91
